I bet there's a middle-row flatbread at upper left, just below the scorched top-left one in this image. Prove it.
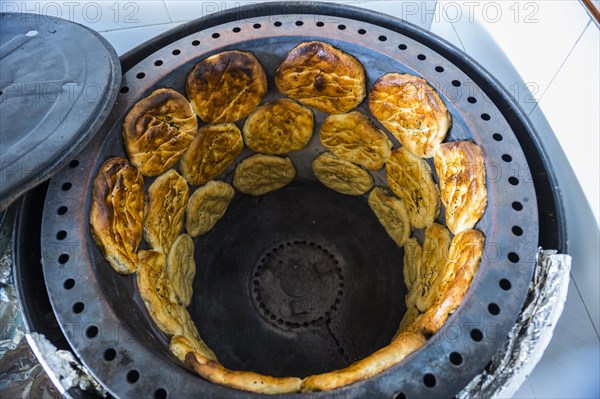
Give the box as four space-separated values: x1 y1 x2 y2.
179 123 244 186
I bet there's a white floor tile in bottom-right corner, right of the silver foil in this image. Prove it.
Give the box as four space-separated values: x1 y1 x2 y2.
529 283 600 399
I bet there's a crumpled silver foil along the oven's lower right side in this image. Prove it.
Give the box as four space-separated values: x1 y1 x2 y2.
457 248 571 399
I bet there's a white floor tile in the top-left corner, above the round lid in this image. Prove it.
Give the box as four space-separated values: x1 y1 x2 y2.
0 0 171 31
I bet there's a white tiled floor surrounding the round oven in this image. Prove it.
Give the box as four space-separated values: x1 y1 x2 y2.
0 0 600 398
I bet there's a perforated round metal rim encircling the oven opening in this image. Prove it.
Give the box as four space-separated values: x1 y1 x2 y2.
28 3 564 397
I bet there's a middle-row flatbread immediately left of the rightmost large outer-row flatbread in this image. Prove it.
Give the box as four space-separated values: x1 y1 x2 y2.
385 147 440 229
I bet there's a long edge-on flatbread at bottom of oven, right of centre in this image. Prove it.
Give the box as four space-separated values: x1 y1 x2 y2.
301 332 427 392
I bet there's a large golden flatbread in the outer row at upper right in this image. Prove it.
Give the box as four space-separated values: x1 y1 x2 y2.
369 73 451 158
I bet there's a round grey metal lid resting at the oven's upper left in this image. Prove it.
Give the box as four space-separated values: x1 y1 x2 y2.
0 13 121 210
